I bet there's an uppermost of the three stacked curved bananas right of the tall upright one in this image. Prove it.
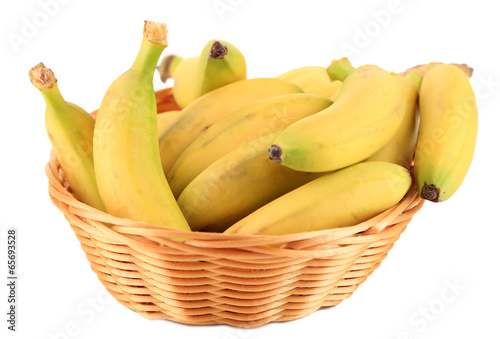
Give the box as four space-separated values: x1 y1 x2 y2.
160 78 302 175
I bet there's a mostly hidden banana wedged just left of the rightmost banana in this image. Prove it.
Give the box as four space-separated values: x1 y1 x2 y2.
366 72 421 169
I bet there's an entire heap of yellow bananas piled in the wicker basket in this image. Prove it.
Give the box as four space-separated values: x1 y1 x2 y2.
35 21 478 241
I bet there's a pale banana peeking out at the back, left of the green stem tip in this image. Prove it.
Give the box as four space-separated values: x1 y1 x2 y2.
276 66 342 98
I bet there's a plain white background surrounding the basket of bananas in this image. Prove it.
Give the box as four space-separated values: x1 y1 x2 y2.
0 0 500 339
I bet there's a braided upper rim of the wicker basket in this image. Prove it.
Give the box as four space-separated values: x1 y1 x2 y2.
45 150 424 254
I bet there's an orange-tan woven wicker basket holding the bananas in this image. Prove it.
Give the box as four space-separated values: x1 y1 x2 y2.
45 154 423 327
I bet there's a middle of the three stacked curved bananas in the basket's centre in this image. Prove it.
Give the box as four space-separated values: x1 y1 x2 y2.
167 93 332 197
